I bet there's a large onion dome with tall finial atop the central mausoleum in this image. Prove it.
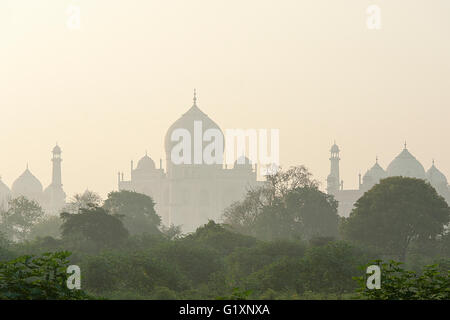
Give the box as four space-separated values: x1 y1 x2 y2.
164 92 225 163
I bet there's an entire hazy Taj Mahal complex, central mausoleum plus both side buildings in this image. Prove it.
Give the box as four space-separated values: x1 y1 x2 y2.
0 92 450 232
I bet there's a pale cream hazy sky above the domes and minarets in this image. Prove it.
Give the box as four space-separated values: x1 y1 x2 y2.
0 0 450 196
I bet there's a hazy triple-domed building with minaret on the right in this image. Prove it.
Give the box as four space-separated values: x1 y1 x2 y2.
327 143 450 217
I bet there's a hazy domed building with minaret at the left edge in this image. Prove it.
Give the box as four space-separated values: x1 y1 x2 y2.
0 145 66 214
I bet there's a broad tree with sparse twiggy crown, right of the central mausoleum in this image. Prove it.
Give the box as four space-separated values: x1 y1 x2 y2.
223 166 339 240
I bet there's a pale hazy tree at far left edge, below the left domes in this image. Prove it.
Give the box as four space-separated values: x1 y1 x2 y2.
1 196 44 241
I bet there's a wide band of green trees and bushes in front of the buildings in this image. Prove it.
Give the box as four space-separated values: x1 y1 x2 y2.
0 166 450 299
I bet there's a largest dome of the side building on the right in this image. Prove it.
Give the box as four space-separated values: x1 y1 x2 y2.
386 146 426 179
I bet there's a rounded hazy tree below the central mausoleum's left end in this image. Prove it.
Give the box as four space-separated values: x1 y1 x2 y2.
103 191 161 235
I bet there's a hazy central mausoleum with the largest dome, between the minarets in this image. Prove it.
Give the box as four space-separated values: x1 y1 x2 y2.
118 93 261 232
